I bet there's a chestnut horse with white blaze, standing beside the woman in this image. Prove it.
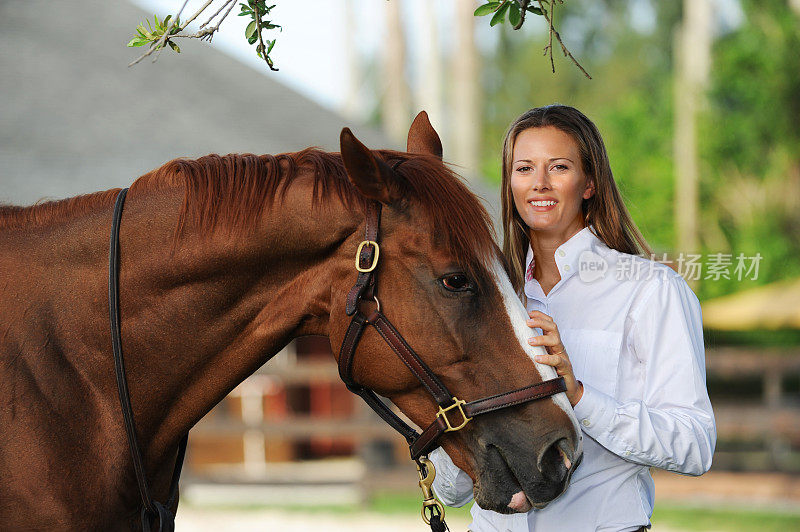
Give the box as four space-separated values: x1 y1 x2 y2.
0 113 581 530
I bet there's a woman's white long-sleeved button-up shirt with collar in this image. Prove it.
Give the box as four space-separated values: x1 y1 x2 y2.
431 227 717 532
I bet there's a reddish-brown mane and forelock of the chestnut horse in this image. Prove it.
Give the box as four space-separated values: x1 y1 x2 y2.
0 148 500 274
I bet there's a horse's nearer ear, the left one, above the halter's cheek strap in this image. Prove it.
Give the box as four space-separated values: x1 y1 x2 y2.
339 127 401 205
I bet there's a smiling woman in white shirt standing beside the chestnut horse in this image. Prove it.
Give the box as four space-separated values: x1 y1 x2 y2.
431 105 716 532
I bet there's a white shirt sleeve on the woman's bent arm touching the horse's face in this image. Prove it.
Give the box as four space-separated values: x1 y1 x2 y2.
575 275 717 475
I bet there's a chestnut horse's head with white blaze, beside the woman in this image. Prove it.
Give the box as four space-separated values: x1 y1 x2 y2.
329 112 581 513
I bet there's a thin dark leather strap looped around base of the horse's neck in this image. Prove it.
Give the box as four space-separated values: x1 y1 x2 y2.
108 188 189 532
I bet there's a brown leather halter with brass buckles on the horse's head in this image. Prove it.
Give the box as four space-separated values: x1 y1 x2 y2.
339 197 567 464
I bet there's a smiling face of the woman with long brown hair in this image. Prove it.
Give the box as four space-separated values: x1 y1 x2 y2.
510 126 594 238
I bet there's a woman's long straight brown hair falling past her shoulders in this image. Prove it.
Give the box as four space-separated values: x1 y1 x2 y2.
501 104 652 293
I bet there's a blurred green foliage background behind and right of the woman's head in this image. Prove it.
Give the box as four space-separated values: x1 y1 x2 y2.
468 0 800 299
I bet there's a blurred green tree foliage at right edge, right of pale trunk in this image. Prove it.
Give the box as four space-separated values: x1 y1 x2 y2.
701 0 800 296
